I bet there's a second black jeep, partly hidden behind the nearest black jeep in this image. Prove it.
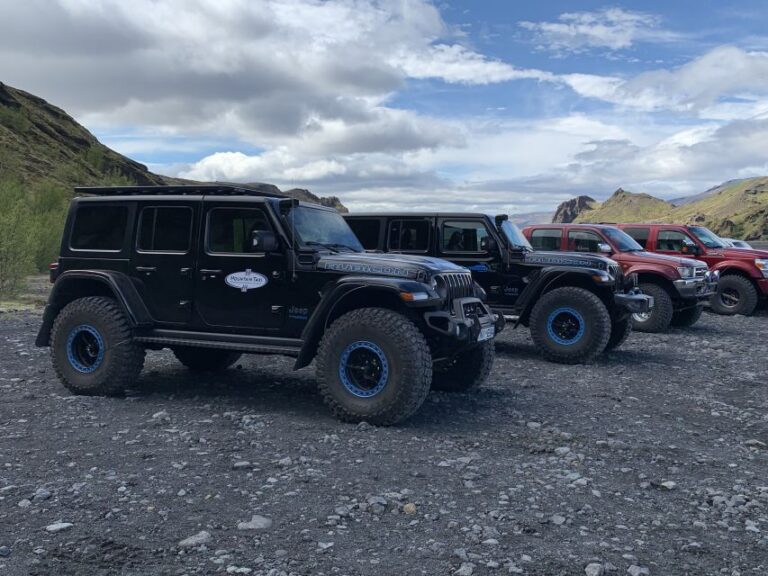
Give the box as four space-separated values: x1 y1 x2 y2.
345 213 653 364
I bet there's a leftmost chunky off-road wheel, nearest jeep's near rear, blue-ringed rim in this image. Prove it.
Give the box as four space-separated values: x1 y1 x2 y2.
51 296 144 396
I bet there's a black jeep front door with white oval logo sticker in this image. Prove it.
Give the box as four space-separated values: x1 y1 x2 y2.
195 200 288 335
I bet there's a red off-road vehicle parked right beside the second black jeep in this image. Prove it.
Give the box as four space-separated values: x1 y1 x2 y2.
523 224 718 332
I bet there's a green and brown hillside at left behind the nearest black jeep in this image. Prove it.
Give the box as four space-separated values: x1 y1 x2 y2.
0 82 347 297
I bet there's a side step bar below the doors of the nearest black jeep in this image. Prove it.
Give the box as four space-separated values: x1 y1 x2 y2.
134 330 304 356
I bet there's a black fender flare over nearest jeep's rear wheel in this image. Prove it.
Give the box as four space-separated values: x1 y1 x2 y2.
35 270 153 347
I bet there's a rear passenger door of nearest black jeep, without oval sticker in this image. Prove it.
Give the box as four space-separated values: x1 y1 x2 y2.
131 201 199 324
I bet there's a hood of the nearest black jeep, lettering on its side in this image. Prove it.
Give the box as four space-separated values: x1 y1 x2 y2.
317 252 469 280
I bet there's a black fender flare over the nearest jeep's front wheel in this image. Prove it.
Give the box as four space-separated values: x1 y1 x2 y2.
294 276 428 370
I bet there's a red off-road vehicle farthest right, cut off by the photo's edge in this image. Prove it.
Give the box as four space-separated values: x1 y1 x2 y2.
617 224 768 316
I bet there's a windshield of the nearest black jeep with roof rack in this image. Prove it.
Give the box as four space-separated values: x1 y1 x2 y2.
285 206 363 252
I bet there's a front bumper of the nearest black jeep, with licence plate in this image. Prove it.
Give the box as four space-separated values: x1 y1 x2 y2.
424 297 505 344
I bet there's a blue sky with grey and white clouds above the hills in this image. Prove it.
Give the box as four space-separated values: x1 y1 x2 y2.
0 0 768 213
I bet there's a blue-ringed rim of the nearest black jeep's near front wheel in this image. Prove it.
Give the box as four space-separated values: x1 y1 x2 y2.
339 340 389 398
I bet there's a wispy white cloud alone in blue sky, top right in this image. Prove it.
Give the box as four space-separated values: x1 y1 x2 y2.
519 8 680 55
